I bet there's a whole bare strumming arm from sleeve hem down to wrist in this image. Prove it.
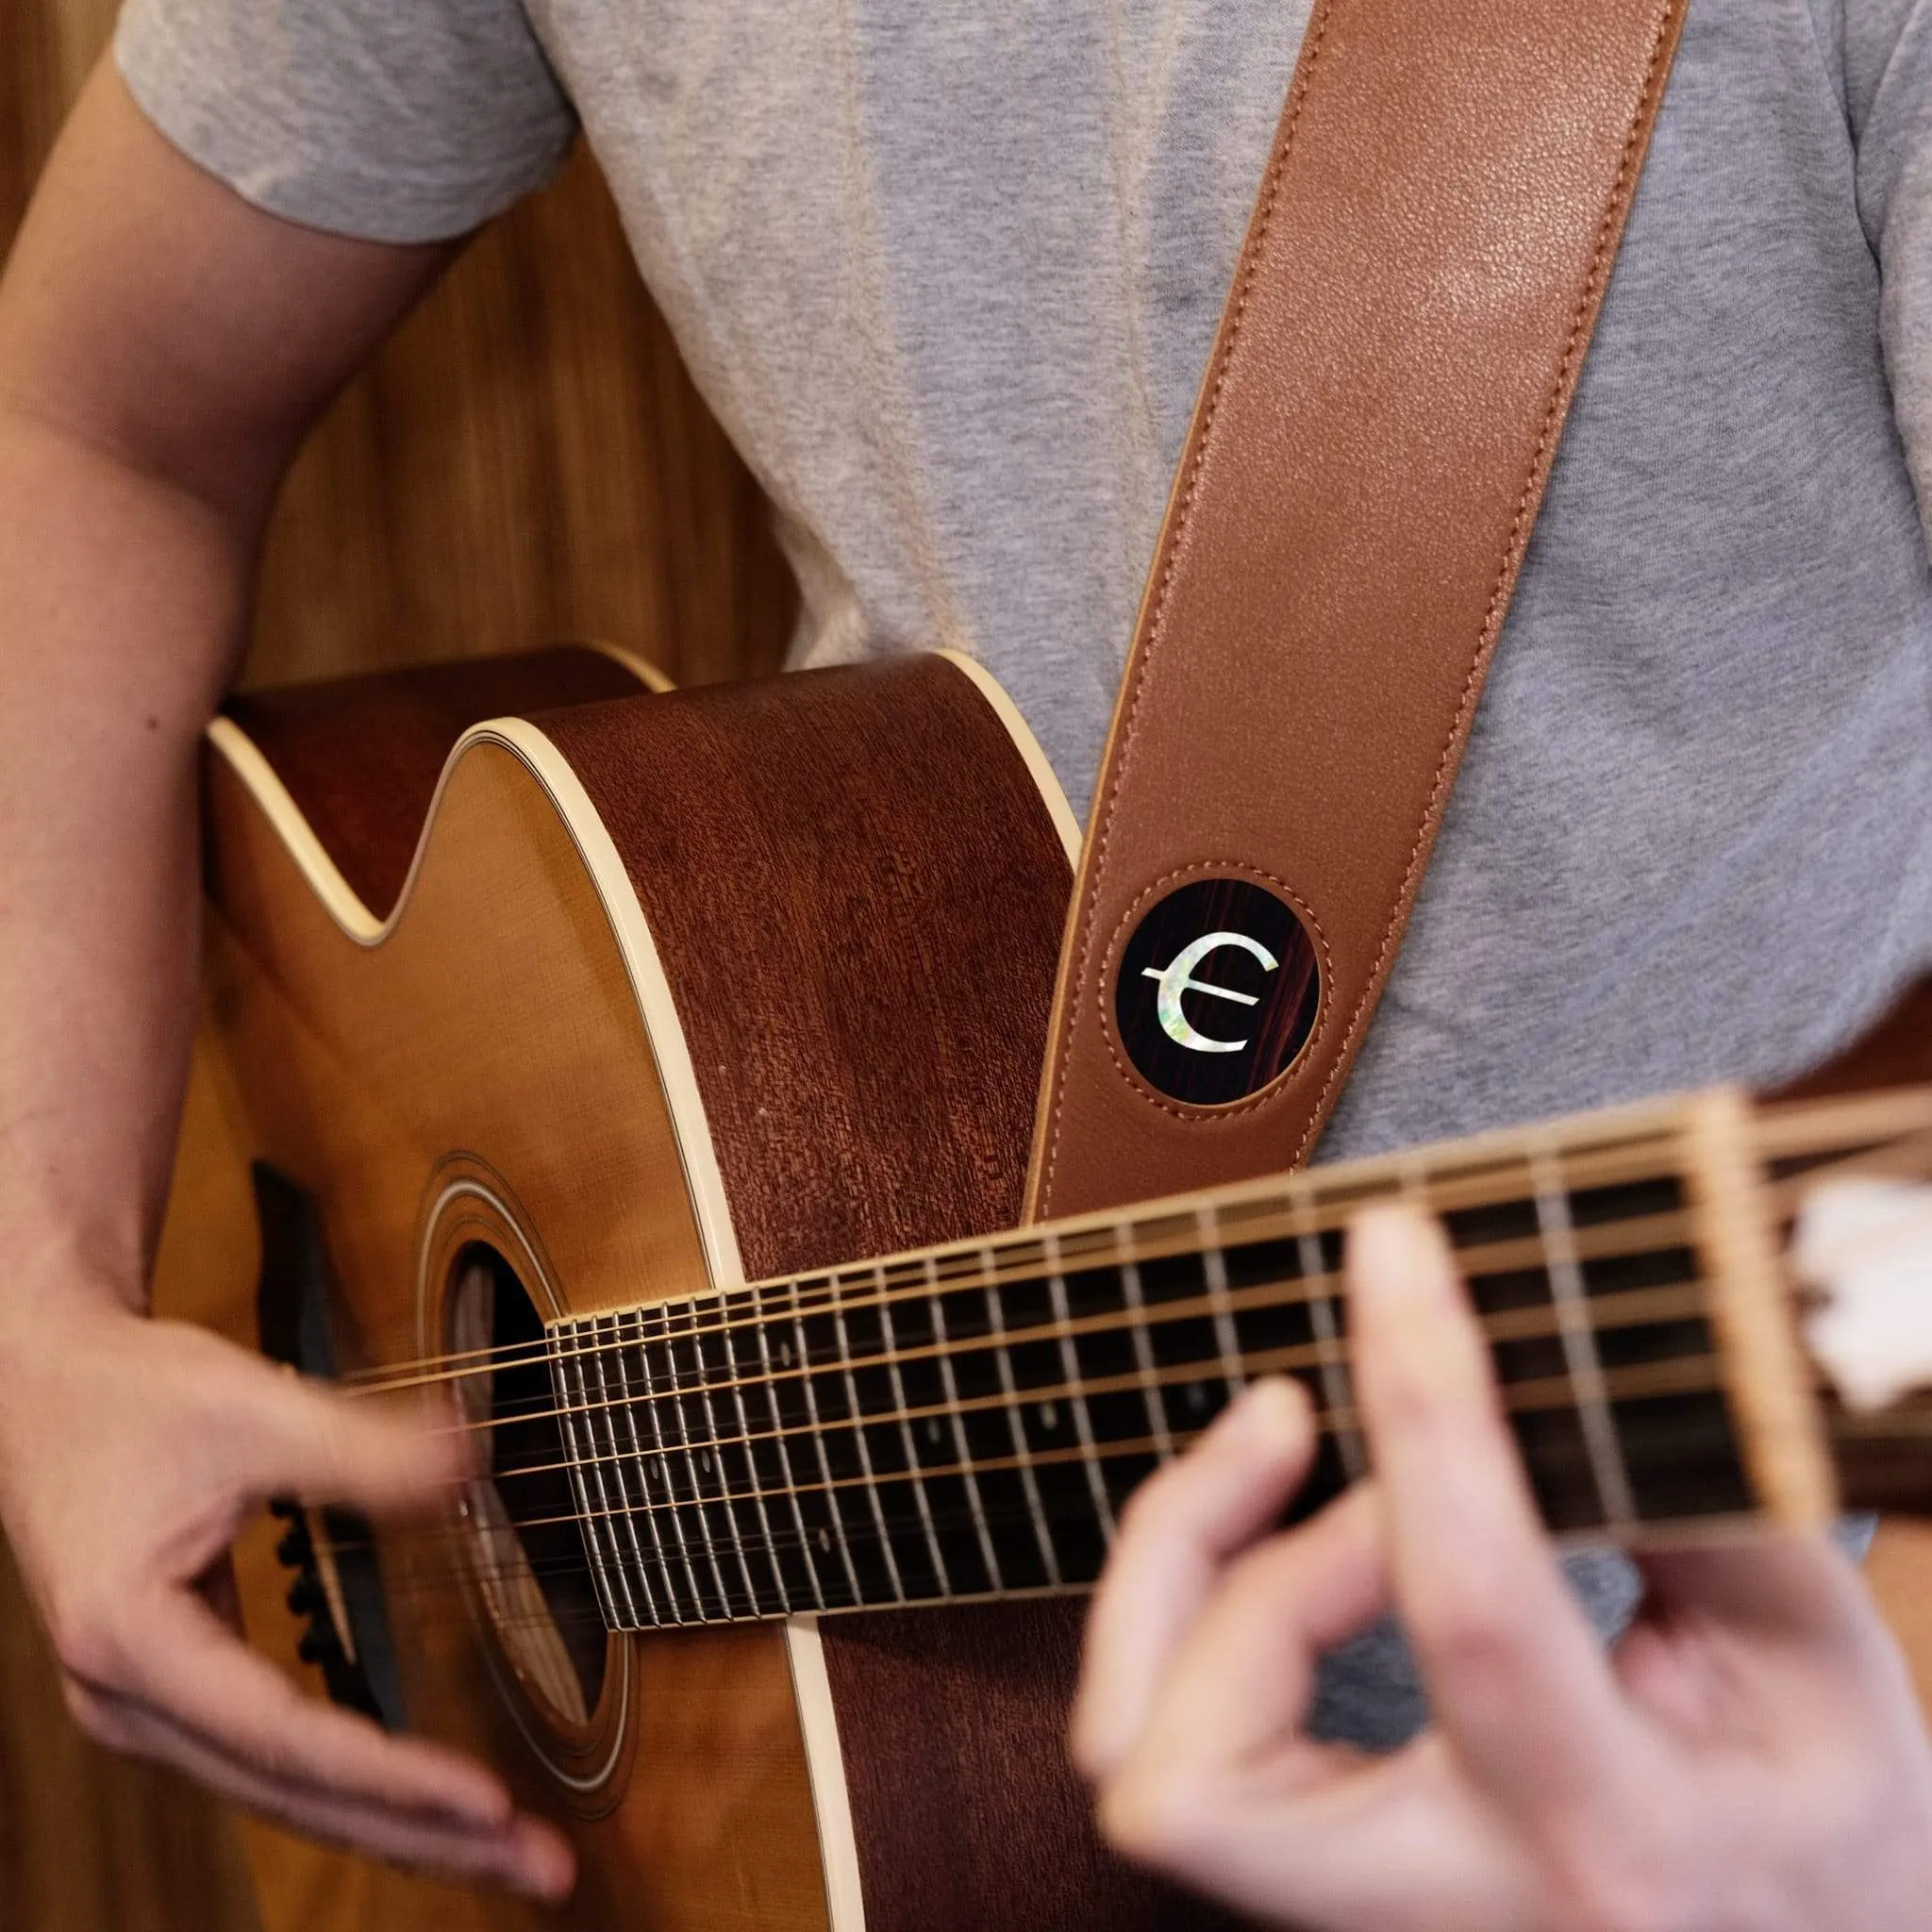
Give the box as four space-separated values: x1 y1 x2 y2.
0 64 452 1322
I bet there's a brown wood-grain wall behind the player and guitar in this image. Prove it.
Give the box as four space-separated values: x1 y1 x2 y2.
0 0 796 1932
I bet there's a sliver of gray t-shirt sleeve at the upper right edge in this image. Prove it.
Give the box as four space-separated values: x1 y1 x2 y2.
1845 0 1932 539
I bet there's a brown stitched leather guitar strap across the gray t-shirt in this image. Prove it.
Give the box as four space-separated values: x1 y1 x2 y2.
1030 0 1689 1215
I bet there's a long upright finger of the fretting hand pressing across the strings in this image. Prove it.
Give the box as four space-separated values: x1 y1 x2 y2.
1349 1206 1628 1803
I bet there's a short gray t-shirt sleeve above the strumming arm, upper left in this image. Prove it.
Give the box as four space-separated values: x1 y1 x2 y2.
114 0 575 242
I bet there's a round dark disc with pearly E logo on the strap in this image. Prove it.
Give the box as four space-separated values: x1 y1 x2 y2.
1113 879 1322 1108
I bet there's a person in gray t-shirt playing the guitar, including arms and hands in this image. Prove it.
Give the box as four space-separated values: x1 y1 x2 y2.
0 0 1932 1932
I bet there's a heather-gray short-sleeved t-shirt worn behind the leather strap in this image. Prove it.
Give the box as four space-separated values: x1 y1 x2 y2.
118 0 1932 1735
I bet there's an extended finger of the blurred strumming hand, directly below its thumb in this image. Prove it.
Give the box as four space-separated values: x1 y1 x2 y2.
96 1591 512 1829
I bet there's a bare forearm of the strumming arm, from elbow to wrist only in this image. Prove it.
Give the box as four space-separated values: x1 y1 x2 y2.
0 406 253 1322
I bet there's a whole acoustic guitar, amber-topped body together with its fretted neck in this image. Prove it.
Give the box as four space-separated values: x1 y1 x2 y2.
188 647 1932 1932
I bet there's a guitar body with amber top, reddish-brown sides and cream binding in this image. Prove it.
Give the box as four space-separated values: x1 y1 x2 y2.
170 651 1219 1932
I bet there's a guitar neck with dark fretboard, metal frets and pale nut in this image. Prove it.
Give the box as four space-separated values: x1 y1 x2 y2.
549 1091 1932 1628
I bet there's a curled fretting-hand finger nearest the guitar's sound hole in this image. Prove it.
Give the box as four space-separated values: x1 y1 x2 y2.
1071 1379 1316 1779
